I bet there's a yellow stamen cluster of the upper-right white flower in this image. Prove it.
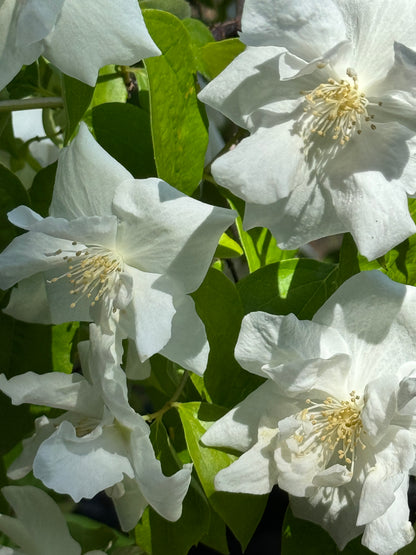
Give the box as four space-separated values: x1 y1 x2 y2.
302 68 376 145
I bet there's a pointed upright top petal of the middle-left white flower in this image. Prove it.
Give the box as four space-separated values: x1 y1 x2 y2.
49 125 133 220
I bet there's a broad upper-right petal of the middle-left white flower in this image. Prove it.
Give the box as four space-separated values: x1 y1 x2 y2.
113 178 235 293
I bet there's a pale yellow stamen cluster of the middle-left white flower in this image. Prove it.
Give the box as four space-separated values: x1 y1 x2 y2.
48 241 123 308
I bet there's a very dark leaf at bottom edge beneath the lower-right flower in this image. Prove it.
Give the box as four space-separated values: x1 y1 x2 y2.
281 508 372 555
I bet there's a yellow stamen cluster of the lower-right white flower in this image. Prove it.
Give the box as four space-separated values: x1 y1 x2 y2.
294 391 365 466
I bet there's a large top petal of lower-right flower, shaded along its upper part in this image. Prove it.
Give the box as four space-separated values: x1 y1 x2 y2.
313 270 416 393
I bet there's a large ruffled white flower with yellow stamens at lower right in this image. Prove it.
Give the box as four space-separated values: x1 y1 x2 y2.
203 271 416 555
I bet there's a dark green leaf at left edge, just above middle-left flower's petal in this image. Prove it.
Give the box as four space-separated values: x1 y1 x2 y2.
0 164 30 251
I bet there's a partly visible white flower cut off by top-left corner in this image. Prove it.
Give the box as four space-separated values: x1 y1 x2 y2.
0 0 160 90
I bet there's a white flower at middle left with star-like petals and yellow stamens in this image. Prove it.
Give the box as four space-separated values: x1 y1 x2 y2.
0 125 234 374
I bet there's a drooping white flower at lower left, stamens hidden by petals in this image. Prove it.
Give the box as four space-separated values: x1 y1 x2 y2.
0 324 192 530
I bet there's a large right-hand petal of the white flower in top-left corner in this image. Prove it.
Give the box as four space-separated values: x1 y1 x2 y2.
44 0 160 87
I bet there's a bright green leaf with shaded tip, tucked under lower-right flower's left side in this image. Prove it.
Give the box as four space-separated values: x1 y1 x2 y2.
178 403 267 550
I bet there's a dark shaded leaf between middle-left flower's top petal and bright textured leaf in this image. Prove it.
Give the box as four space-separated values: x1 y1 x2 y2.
92 102 156 179
